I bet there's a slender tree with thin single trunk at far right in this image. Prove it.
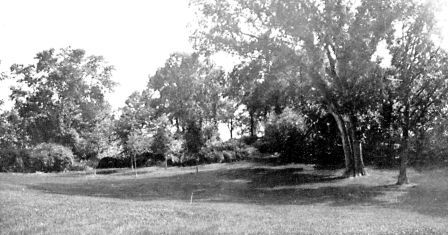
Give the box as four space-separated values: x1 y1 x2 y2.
385 4 448 184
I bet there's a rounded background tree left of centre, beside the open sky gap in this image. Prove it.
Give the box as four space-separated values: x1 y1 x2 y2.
148 54 224 132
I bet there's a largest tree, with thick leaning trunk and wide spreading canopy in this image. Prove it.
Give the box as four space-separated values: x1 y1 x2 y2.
192 0 400 176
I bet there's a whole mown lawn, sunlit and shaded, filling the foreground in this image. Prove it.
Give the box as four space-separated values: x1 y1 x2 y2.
0 162 448 234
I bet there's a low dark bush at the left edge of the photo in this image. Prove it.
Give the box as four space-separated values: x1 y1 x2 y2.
0 148 29 172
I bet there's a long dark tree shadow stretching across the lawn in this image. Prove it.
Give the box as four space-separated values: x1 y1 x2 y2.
21 162 448 217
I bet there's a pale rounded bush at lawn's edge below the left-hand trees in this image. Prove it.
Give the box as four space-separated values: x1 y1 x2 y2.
30 143 73 172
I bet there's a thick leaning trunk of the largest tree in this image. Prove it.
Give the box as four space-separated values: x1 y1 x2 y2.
331 112 366 177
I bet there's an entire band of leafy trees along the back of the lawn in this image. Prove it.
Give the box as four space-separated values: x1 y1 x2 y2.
0 0 448 184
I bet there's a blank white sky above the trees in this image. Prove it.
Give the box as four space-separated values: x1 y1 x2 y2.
0 0 448 111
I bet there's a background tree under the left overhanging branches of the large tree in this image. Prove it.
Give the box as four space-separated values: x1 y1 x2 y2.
225 51 307 136
